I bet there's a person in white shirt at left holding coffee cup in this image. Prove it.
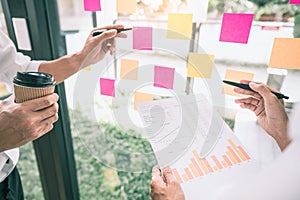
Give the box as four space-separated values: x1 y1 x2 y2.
0 25 126 199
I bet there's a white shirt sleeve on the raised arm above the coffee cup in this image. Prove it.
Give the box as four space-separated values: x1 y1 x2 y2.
0 31 45 85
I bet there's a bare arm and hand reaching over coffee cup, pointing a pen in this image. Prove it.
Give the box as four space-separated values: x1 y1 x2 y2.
39 25 126 83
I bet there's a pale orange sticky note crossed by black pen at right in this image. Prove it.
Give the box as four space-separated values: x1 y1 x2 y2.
223 69 254 96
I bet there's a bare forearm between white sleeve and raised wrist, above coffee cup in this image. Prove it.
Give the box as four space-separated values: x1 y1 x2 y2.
39 53 84 84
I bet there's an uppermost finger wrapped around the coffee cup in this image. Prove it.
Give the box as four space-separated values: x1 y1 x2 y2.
22 93 59 111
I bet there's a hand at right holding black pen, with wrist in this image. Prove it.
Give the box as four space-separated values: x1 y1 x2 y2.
234 81 291 150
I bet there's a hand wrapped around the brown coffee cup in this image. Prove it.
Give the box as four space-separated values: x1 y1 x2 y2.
0 94 58 152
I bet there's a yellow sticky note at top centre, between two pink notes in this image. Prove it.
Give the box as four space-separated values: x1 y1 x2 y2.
167 14 193 40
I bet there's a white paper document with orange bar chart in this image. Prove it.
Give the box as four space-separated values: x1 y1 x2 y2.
137 94 258 200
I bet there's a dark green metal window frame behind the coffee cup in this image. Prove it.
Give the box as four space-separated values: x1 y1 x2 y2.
1 0 79 200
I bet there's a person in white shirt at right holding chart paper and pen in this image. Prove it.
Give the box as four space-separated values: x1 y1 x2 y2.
150 81 300 200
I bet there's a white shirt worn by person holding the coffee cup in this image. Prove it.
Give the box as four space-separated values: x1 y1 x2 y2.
0 31 43 182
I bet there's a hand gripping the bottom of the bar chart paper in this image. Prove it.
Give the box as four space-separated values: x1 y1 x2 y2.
150 167 185 200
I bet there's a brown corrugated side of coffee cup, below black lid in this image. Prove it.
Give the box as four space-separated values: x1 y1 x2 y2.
14 84 55 103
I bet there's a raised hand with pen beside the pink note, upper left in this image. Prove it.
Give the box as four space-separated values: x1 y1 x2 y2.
79 25 127 69
